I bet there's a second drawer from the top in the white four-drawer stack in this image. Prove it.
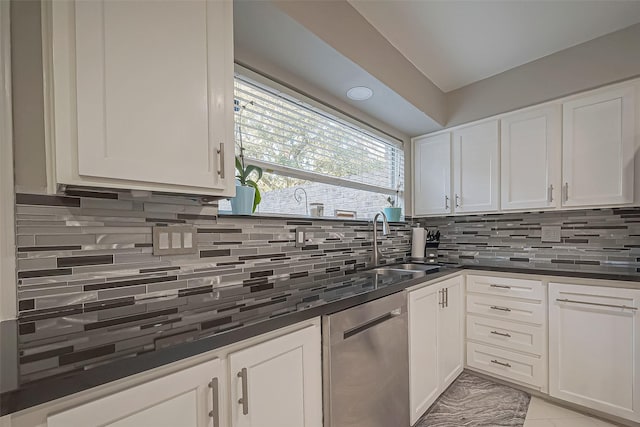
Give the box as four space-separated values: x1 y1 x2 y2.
467 295 546 325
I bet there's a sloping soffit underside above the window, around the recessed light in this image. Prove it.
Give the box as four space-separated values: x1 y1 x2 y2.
233 0 441 135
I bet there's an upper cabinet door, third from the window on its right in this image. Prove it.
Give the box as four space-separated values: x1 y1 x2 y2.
500 104 562 210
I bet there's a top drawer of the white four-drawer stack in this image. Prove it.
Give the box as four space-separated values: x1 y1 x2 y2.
467 275 545 301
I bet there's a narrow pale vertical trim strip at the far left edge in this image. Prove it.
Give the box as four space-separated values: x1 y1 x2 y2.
0 1 17 320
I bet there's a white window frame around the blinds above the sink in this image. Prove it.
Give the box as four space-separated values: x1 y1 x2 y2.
235 64 407 199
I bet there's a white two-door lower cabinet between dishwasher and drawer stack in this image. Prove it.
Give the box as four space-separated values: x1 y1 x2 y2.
409 276 464 424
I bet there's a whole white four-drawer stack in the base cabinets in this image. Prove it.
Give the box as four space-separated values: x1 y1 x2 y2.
466 275 547 392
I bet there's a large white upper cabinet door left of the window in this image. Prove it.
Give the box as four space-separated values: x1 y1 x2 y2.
75 0 233 188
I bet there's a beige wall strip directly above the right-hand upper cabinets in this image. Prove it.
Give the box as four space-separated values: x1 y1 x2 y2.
446 24 640 127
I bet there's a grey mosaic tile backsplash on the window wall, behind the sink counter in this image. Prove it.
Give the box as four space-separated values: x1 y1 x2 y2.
16 191 411 318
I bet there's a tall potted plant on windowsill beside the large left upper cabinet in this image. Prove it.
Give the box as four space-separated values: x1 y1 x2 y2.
229 100 262 215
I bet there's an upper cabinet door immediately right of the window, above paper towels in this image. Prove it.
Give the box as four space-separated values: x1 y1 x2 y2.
413 132 453 215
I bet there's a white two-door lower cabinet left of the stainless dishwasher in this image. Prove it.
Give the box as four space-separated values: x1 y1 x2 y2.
45 321 322 427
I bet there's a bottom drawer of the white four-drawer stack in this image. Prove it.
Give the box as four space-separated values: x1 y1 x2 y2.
467 342 546 389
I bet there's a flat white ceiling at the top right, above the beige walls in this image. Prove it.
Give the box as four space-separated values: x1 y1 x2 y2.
349 0 640 92
